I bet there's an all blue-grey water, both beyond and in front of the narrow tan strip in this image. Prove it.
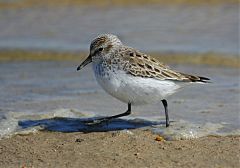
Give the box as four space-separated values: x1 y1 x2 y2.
0 4 240 139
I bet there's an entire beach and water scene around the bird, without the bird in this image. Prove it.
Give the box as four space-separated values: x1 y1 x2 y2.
0 0 240 167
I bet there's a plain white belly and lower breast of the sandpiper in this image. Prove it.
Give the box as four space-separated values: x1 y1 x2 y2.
95 65 180 105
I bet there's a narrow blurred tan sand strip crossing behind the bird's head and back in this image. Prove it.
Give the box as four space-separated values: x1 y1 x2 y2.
0 49 240 68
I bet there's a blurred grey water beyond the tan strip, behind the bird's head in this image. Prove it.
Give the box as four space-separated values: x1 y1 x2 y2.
0 4 239 54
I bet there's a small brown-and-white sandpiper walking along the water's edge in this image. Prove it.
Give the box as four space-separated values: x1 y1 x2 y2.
77 34 209 127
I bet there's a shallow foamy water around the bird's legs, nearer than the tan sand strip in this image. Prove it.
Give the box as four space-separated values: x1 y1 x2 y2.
0 62 240 139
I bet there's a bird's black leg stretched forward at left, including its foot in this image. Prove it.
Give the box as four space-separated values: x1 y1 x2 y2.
87 103 131 125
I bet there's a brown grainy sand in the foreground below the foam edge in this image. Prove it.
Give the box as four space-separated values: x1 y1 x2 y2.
0 129 240 167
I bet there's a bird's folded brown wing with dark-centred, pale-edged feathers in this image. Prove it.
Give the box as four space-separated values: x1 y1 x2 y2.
119 48 209 82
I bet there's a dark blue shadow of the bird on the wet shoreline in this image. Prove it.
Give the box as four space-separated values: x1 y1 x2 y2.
18 117 162 133
